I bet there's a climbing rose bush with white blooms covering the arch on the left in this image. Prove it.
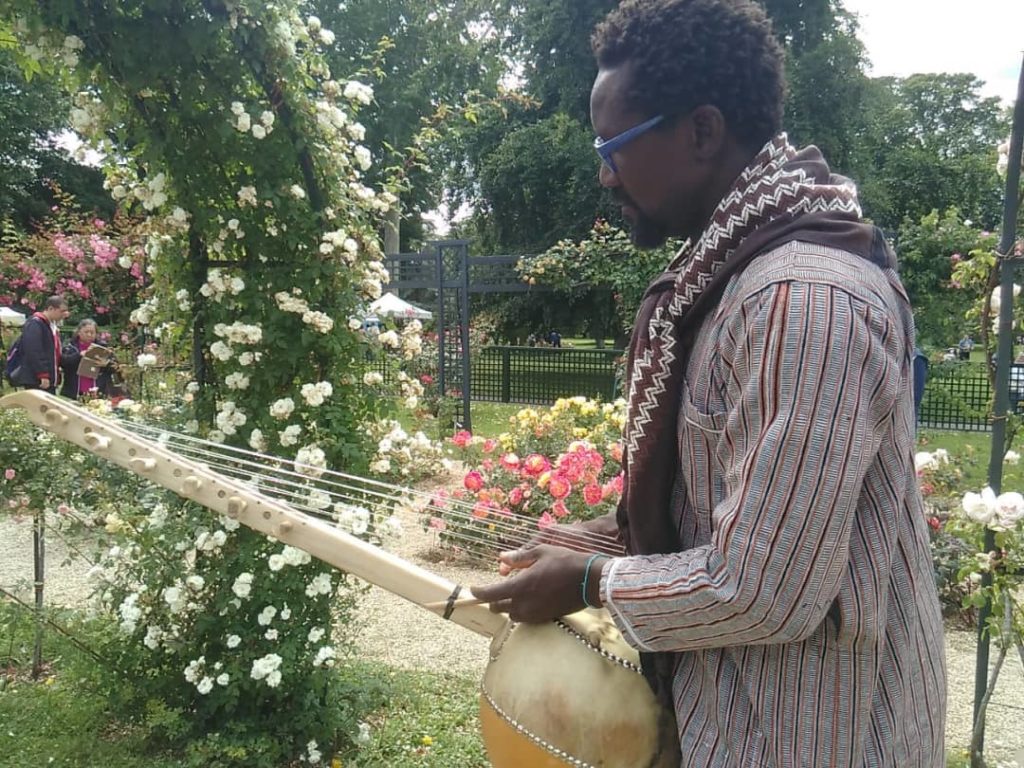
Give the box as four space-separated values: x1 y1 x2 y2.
0 0 419 767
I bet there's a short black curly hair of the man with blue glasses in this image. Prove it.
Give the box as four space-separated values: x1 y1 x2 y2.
591 0 785 148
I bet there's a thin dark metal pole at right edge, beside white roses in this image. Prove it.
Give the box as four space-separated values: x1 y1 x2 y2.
971 54 1024 768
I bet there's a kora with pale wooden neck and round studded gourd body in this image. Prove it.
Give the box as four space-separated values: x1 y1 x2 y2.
8 390 679 768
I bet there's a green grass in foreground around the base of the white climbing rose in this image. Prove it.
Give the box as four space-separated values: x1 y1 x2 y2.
0 603 488 768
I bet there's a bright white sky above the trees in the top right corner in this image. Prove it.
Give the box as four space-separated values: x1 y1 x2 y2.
843 0 1024 102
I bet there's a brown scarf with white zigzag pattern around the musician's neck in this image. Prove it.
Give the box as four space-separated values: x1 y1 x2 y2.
617 134 895 702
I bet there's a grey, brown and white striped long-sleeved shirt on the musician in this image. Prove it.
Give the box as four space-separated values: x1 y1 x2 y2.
601 243 946 768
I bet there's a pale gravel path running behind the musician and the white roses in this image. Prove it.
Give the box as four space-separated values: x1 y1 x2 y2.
0 517 1024 768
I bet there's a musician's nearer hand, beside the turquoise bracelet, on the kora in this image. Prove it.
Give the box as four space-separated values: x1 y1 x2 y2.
471 544 600 624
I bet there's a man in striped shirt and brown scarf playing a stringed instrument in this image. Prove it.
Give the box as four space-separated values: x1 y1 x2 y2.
473 0 946 768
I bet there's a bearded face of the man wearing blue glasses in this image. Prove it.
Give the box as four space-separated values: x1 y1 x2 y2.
590 63 705 248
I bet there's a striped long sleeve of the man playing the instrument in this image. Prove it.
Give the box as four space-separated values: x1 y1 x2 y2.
601 282 910 651
